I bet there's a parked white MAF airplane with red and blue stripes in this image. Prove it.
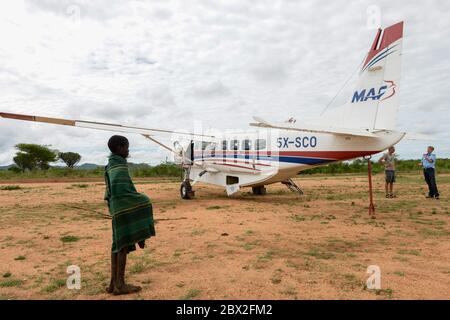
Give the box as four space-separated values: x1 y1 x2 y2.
0 21 405 199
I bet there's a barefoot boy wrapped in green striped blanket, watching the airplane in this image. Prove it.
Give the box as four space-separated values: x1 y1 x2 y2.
105 136 155 295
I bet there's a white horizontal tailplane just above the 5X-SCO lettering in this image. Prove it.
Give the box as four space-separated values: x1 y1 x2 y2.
250 117 377 138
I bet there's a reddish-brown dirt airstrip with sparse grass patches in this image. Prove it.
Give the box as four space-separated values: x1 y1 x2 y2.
0 172 450 299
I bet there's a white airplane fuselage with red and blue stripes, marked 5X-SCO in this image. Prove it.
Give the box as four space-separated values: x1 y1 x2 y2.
189 129 404 187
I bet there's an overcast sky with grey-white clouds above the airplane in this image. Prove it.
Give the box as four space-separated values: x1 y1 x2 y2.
0 0 450 165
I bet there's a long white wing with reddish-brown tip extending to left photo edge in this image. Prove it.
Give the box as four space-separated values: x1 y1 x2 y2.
0 112 214 141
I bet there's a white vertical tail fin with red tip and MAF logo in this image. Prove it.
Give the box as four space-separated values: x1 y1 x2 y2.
326 22 403 131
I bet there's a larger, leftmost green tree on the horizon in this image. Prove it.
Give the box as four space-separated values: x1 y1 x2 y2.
13 143 57 171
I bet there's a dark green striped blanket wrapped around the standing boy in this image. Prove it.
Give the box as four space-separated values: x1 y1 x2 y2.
105 155 155 252
